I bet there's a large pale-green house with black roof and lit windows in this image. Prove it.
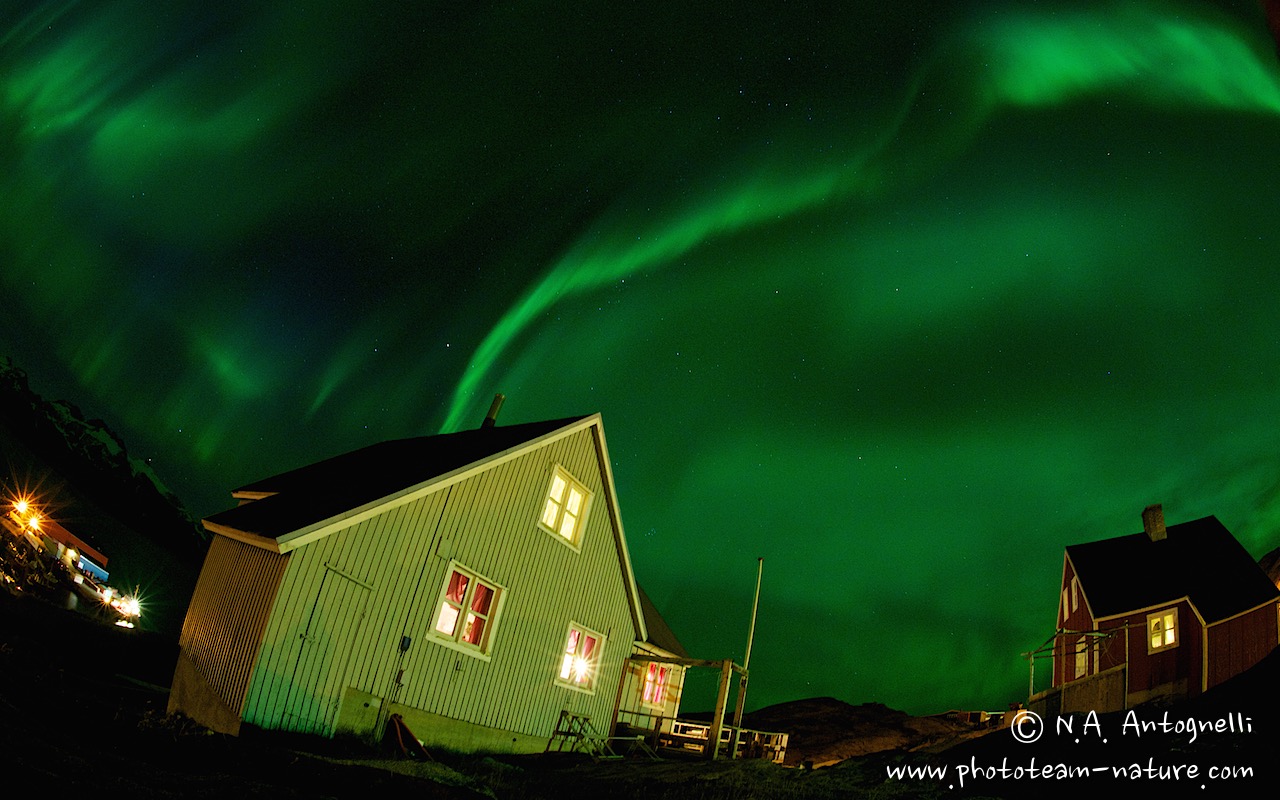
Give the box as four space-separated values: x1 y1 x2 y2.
170 415 670 750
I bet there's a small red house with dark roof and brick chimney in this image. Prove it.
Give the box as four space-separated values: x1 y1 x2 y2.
1032 506 1280 713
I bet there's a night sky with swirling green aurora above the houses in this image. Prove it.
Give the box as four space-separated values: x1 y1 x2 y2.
0 0 1280 712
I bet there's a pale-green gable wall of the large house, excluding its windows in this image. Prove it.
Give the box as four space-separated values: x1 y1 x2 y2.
243 429 637 736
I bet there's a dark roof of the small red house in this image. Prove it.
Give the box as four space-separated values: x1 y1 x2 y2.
1066 516 1280 623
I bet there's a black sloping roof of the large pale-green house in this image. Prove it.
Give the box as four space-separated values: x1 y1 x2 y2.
205 416 590 540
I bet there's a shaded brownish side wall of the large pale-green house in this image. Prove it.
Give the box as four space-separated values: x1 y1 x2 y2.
180 536 289 712
